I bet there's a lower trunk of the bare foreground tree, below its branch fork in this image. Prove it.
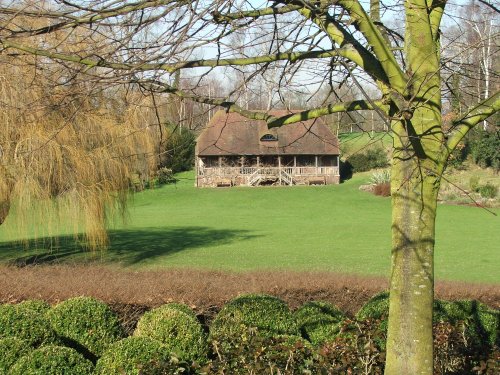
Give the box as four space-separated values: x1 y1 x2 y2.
385 149 439 375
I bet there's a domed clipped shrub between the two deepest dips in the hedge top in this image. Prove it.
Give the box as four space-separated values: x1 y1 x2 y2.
134 305 207 362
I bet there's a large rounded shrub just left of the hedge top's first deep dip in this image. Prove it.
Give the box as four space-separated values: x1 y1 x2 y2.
47 297 124 359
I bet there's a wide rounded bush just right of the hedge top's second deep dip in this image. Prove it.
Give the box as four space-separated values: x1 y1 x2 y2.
210 294 299 346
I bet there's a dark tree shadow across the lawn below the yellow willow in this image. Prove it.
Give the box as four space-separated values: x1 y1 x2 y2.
0 227 256 267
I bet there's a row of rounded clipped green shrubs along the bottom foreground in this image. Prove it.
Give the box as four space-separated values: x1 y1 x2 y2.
0 293 500 375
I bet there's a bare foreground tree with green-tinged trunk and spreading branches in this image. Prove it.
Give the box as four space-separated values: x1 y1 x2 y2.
0 0 500 375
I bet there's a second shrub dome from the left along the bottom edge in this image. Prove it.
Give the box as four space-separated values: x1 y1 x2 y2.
9 345 94 375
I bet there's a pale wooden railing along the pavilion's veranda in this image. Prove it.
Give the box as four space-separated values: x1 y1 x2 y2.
198 167 339 177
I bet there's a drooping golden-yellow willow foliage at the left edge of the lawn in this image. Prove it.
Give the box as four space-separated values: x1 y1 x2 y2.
0 64 156 249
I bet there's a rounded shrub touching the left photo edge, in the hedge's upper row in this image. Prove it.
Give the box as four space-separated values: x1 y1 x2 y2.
0 304 57 347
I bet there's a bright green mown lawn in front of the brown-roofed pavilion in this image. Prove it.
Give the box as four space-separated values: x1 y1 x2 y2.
0 173 500 283
